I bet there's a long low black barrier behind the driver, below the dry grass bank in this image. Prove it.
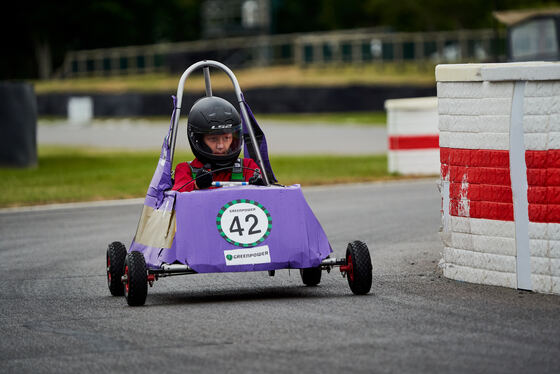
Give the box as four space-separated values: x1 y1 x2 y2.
37 85 436 119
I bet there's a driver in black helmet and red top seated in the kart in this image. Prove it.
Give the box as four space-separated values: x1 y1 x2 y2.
173 96 264 192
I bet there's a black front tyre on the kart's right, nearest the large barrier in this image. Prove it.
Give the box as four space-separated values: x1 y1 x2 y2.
346 240 372 295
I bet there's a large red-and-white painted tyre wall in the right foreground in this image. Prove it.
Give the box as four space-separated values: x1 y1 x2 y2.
436 62 560 294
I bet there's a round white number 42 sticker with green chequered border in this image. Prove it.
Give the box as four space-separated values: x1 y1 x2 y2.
216 199 272 247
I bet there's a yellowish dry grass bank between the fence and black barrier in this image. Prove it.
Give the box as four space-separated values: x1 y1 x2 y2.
32 63 435 95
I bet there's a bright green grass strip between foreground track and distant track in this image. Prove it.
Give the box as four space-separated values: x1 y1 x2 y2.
0 147 396 207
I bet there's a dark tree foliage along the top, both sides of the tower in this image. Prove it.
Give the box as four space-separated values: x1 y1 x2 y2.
0 0 557 79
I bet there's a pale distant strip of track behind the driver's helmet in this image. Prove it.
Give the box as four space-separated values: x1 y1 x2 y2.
37 119 387 155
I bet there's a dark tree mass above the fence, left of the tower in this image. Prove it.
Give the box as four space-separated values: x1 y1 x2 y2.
0 0 201 79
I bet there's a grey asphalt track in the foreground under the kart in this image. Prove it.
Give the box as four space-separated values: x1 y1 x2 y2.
0 180 560 374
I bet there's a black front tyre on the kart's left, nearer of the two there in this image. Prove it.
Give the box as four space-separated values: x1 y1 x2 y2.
124 251 148 306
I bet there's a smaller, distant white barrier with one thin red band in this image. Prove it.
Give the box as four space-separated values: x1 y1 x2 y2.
385 97 439 175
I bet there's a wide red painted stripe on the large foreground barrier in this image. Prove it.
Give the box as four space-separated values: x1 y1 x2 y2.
440 148 560 223
